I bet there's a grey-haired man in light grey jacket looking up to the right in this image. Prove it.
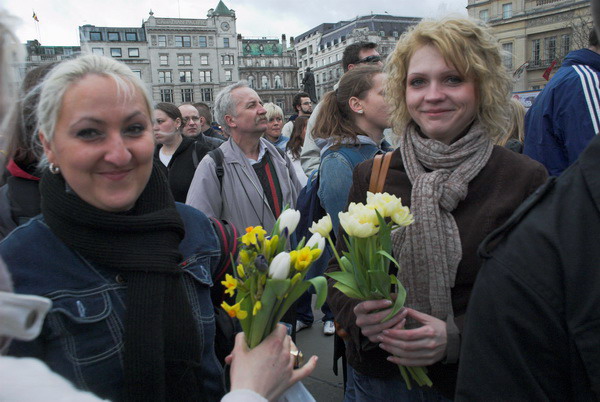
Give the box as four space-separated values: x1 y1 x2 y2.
186 81 301 232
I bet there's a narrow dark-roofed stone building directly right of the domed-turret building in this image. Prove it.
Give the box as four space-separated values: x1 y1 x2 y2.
238 35 300 115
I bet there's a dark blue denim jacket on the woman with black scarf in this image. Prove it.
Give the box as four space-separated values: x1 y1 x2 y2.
0 204 224 401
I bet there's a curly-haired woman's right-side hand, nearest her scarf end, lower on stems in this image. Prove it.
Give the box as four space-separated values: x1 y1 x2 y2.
377 308 447 366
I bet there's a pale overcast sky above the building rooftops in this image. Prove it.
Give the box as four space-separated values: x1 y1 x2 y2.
0 0 467 46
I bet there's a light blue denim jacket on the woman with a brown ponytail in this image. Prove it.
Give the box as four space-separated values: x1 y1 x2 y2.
318 135 390 234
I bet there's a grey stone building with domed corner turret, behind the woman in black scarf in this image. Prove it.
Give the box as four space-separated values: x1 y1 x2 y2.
79 1 239 105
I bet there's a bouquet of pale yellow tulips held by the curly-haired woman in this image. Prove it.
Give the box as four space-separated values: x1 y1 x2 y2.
322 192 432 389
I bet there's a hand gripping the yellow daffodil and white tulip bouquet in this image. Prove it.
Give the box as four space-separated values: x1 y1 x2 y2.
225 324 317 400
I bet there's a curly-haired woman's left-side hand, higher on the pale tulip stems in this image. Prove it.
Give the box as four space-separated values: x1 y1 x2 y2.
354 300 406 343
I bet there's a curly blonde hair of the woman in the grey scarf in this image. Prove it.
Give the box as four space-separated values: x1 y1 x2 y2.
385 17 513 139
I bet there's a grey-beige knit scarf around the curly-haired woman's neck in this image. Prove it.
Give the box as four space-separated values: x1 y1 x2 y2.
392 121 493 320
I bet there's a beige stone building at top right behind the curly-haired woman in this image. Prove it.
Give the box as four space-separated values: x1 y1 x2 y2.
467 0 592 92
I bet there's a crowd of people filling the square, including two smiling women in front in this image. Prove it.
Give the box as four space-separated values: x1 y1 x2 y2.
0 1 600 402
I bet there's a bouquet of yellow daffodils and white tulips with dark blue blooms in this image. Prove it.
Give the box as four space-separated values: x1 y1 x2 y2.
221 209 327 348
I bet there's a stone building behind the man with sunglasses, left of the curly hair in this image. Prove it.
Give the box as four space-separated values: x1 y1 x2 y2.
295 14 421 99
